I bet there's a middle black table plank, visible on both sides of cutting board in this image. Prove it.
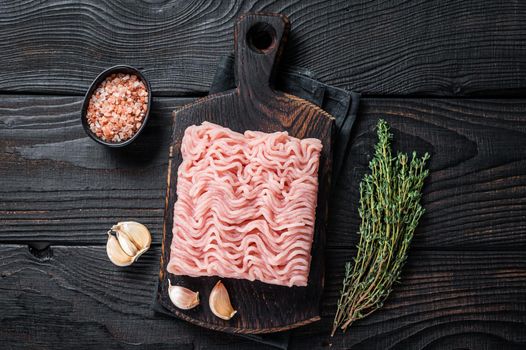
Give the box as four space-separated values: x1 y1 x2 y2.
0 96 526 250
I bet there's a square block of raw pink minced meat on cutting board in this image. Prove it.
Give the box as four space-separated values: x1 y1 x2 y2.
168 122 322 287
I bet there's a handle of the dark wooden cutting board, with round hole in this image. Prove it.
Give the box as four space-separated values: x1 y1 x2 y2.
234 13 290 98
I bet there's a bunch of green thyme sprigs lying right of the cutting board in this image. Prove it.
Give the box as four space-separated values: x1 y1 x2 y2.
331 120 429 335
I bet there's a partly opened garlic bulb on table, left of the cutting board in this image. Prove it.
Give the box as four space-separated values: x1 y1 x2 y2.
106 221 152 266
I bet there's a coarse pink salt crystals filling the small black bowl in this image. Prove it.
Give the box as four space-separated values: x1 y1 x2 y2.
86 73 148 142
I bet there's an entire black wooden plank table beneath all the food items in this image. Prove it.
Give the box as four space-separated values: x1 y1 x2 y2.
0 0 526 349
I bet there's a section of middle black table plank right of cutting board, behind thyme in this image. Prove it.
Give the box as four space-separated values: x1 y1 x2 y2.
328 99 526 250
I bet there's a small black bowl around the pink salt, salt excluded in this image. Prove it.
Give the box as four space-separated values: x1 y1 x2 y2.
80 65 152 148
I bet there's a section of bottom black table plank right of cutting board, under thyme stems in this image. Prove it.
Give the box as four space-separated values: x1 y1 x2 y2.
291 249 526 350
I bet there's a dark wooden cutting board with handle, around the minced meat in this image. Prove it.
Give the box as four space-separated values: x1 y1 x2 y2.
157 13 334 333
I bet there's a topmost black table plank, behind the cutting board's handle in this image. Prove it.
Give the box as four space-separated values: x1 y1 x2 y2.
0 0 526 96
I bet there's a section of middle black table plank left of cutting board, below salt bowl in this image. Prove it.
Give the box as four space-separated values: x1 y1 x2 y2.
0 96 190 244
